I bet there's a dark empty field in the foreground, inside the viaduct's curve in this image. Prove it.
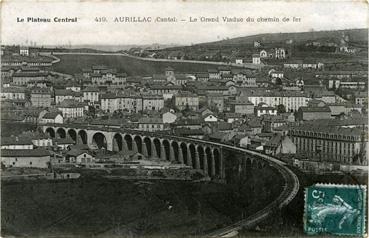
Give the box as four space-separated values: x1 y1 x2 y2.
1 163 281 237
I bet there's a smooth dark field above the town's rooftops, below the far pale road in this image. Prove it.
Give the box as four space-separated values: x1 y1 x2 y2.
52 55 233 76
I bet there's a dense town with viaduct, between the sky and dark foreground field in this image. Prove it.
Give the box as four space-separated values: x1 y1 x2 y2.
1 27 368 234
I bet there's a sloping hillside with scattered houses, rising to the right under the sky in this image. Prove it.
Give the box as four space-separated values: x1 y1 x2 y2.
140 29 368 62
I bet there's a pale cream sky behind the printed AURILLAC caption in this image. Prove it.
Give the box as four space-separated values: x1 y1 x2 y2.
1 0 368 45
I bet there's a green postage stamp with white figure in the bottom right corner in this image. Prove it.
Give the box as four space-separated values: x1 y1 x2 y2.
304 184 366 236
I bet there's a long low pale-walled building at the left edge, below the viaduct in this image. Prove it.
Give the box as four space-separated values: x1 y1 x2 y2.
1 148 50 168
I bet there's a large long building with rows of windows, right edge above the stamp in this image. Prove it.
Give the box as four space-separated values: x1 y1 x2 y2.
288 122 368 165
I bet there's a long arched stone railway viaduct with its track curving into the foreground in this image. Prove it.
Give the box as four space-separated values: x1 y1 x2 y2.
41 124 299 237
